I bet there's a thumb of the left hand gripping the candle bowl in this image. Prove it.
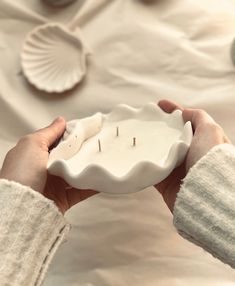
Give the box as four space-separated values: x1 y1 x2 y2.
35 117 66 147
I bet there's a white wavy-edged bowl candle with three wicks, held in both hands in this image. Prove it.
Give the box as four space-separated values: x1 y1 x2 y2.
48 103 192 193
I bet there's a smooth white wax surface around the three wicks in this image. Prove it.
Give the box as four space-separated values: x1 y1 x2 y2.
67 119 181 177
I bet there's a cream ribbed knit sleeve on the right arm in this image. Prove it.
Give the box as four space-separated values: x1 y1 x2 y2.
173 144 235 268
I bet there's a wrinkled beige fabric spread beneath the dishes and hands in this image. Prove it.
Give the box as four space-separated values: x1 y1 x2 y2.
0 0 235 286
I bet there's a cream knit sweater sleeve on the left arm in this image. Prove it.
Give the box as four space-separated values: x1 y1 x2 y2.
0 179 70 286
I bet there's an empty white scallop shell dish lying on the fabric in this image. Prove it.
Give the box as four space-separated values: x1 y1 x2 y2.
21 23 89 93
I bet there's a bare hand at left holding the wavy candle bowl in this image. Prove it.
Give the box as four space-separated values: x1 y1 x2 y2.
0 117 97 213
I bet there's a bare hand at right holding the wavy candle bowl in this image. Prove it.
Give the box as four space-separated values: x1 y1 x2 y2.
155 100 231 212
